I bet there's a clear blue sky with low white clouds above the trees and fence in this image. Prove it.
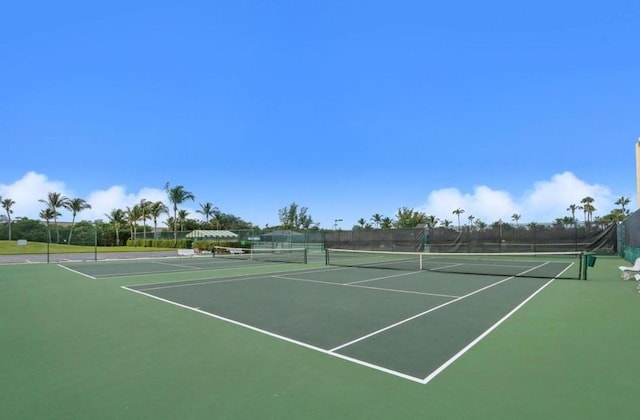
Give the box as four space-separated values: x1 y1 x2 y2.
0 0 640 228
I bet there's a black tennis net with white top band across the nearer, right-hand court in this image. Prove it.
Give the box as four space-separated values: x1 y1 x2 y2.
326 249 584 279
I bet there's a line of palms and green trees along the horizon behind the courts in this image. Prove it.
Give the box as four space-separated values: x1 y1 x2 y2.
0 189 631 246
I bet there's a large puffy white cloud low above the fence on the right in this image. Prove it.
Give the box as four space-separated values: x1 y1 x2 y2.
419 172 615 223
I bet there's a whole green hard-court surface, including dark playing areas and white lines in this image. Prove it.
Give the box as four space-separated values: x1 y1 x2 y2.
0 255 640 420
